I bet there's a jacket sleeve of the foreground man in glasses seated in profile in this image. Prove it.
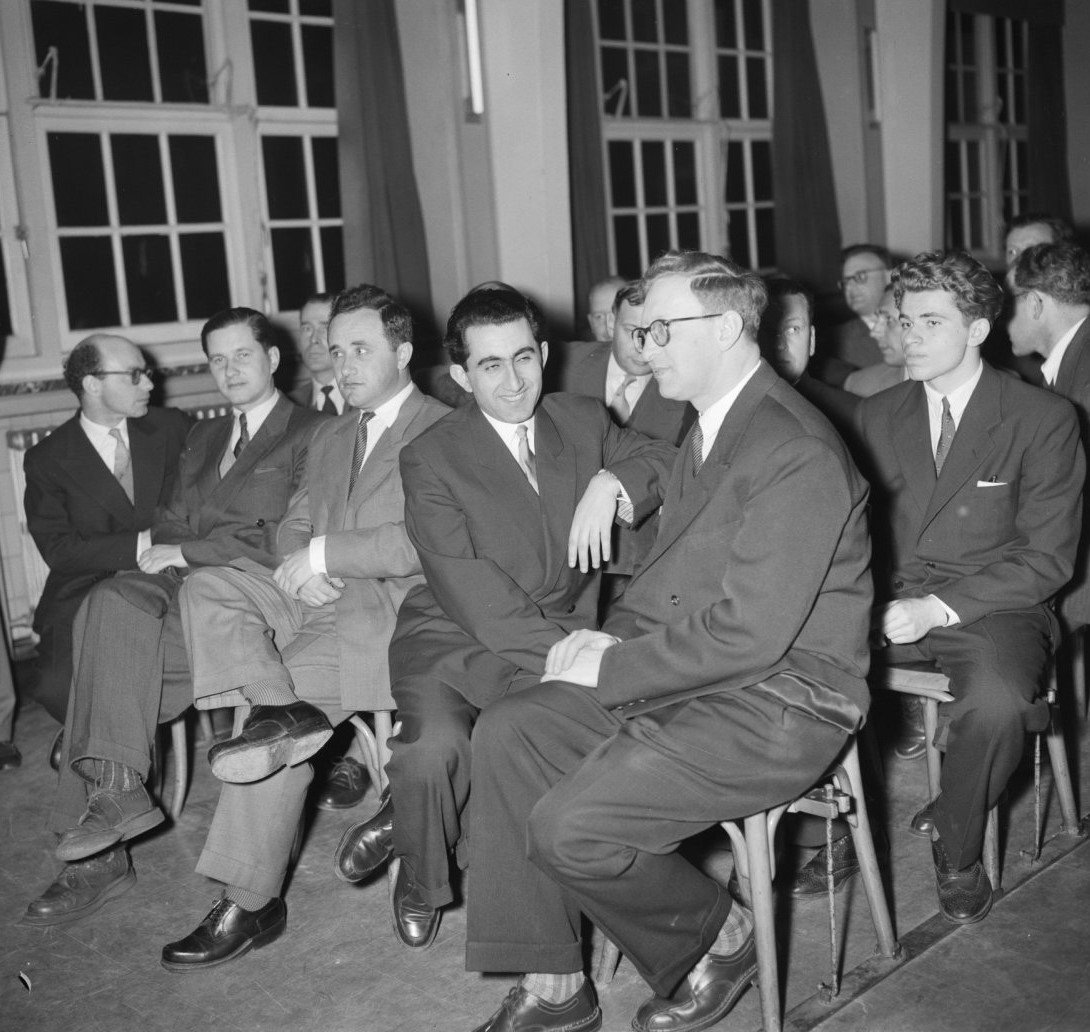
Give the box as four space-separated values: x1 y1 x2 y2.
597 437 867 706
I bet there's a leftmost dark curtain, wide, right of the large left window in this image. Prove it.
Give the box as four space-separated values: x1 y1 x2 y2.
334 0 438 343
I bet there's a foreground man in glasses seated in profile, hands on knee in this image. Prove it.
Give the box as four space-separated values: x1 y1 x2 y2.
467 252 871 1032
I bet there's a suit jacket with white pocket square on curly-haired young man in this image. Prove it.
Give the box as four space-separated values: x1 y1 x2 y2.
857 363 1085 623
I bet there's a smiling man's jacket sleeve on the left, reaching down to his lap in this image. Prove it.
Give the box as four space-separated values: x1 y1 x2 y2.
401 446 567 673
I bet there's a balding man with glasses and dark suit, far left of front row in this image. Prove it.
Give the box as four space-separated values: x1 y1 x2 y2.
23 333 191 724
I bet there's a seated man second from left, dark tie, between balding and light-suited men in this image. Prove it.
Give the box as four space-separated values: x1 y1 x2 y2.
23 308 323 924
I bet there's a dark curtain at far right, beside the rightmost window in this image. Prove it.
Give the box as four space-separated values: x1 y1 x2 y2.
1026 23 1071 222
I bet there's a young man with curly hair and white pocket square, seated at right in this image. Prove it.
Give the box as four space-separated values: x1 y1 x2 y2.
858 251 1085 923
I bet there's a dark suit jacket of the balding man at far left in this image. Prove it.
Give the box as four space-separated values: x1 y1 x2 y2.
23 409 192 635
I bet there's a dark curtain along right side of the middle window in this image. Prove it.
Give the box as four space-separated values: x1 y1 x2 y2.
772 0 840 292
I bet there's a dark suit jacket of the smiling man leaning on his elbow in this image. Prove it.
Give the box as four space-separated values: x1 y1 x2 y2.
390 394 676 707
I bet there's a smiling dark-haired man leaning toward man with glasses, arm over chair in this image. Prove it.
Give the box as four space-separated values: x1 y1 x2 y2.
336 290 676 947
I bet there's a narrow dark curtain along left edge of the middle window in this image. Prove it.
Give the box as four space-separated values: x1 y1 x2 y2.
564 0 610 327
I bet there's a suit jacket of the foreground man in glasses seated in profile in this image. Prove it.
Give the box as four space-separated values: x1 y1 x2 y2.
595 361 872 725
